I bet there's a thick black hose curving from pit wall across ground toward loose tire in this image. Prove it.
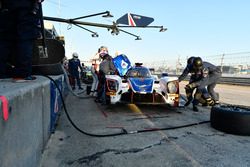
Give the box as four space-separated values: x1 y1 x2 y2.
44 75 210 137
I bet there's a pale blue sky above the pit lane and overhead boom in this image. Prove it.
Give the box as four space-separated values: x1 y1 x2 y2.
43 0 250 66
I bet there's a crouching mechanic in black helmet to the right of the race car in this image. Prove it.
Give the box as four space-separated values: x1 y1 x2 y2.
183 57 222 111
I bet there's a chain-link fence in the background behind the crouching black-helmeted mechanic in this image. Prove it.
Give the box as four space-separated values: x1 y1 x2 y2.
144 52 250 77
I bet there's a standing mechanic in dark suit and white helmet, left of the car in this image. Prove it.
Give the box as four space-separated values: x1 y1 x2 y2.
68 52 83 90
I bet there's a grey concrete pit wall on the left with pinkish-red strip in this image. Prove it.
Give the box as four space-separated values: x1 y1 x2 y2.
0 76 63 167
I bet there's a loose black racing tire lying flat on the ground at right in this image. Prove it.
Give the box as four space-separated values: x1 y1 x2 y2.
210 105 250 136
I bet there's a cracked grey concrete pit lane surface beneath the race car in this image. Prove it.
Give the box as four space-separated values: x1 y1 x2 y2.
41 83 250 167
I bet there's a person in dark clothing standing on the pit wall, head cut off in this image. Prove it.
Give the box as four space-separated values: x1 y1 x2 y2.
0 0 41 82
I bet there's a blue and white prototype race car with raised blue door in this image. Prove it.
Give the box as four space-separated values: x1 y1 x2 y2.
106 55 180 107
